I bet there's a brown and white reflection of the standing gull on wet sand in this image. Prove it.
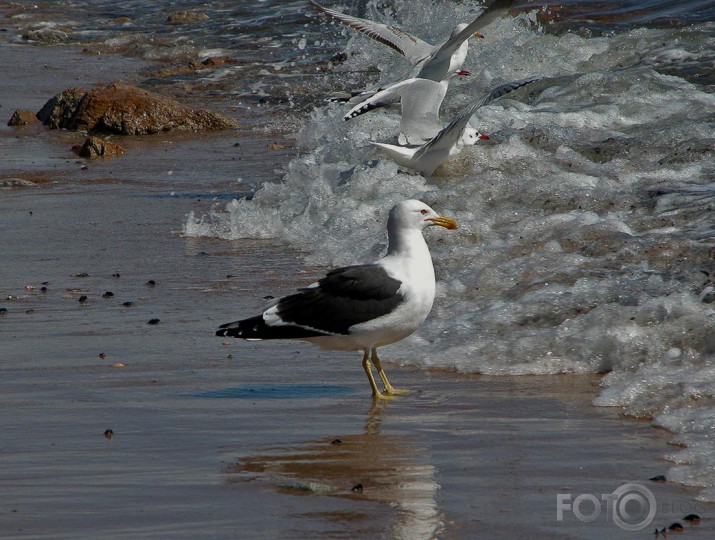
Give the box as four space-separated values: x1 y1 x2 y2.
226 400 443 539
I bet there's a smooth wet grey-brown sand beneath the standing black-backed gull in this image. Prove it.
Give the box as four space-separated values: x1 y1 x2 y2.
0 40 715 539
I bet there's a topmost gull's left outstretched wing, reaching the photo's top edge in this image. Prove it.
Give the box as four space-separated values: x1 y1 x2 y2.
310 0 434 65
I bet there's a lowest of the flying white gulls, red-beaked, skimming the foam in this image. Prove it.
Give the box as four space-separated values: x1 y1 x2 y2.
372 78 538 176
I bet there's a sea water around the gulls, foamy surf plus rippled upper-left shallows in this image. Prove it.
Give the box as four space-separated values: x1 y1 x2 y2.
2 1 715 516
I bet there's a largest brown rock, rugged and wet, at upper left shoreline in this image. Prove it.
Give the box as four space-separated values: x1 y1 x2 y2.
37 83 240 135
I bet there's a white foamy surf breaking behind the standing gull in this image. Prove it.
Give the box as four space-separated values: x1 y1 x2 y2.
184 2 715 500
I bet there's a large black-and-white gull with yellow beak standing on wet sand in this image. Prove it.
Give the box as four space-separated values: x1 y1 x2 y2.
216 200 457 398
